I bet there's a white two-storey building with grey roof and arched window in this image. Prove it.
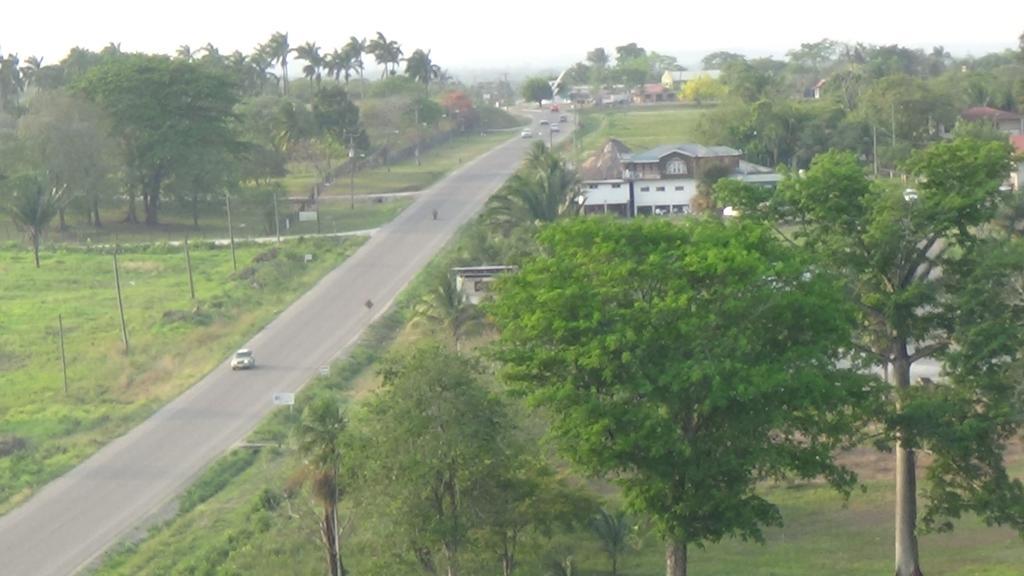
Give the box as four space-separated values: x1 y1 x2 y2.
580 139 781 217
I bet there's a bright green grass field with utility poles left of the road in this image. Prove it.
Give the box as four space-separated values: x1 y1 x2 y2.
0 238 362 512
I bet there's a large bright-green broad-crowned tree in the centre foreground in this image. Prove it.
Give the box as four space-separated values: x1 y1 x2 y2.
487 218 874 576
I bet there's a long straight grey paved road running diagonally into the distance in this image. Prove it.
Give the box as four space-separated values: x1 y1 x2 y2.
0 108 566 576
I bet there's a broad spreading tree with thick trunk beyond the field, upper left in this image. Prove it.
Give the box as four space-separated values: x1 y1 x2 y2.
77 55 238 225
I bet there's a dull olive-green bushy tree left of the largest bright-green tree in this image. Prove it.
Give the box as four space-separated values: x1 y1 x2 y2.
353 344 516 576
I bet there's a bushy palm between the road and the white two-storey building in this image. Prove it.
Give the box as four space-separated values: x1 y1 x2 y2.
484 142 580 233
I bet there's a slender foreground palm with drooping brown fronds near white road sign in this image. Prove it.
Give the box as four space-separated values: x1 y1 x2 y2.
296 397 345 576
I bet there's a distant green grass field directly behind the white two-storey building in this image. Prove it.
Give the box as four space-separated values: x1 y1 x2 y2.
581 106 713 156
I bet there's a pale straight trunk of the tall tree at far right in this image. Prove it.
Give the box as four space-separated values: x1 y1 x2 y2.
892 352 922 576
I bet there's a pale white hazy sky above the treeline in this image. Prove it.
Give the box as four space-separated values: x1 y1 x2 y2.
0 0 1024 70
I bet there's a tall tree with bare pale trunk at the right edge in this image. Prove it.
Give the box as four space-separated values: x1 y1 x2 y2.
716 138 1024 576
